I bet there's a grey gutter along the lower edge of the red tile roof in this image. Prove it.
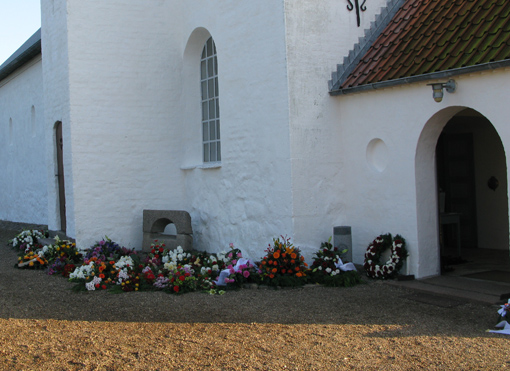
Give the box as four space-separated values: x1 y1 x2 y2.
329 59 510 96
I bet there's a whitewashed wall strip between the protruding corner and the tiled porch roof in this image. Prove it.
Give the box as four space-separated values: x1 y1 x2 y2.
285 0 386 260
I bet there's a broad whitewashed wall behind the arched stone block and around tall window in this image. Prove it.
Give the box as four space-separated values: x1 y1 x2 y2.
53 0 292 258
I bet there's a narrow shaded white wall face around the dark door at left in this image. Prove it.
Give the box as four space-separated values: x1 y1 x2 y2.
41 0 75 237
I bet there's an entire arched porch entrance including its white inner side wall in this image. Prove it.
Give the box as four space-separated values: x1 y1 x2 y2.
415 107 509 279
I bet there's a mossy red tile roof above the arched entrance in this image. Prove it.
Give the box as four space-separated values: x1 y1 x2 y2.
333 0 510 94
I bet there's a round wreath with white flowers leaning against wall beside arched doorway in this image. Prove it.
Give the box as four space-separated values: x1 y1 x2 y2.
363 233 408 279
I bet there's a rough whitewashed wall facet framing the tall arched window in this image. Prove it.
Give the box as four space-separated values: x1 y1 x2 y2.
176 0 294 259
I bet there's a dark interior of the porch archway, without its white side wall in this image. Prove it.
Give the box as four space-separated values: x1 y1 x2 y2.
436 109 509 273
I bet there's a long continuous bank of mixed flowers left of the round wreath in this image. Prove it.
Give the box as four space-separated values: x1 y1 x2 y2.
11 231 366 294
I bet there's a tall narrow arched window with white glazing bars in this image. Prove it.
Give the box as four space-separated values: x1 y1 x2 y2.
200 37 221 162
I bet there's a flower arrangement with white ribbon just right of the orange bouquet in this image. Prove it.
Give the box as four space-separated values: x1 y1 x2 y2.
310 237 361 287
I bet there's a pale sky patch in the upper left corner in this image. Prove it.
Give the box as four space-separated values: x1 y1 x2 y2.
0 0 41 65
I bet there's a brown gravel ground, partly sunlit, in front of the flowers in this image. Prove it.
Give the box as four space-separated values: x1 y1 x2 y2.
0 221 510 370
